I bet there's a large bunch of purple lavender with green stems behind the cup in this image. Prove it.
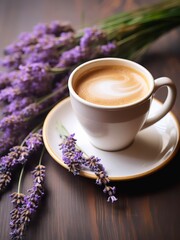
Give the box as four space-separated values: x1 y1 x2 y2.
0 0 180 239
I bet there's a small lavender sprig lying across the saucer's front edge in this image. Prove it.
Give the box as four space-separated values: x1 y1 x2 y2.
60 131 117 203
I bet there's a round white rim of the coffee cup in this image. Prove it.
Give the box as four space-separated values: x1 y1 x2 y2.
68 57 154 110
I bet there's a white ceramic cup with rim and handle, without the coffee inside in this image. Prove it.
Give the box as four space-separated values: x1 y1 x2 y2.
68 58 176 151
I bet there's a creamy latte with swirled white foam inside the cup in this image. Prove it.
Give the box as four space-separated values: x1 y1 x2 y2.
74 66 149 106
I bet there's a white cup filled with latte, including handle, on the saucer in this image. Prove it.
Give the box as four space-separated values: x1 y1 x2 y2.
68 58 176 151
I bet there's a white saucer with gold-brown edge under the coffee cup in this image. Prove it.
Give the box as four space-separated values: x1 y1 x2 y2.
43 98 180 180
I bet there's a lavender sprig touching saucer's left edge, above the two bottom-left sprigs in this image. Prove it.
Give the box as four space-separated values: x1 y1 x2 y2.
0 130 43 192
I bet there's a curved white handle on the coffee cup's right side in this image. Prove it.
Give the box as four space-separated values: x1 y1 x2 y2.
142 77 177 129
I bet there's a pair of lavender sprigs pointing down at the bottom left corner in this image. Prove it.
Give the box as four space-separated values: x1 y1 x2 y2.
10 164 45 240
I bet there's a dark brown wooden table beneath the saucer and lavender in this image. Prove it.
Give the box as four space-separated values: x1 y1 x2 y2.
0 0 180 240
